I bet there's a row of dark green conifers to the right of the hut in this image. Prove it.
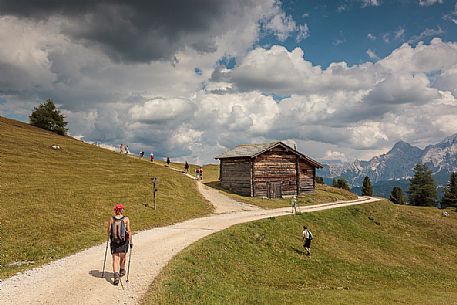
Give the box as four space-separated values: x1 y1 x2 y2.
332 163 457 208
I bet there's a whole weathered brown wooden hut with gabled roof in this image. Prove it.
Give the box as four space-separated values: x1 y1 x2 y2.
216 142 322 198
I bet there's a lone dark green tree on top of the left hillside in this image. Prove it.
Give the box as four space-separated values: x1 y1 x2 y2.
29 99 68 136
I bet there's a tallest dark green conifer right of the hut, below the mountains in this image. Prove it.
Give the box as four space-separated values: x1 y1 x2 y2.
408 163 437 206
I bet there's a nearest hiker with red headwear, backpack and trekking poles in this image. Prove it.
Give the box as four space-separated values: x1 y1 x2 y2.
108 203 133 285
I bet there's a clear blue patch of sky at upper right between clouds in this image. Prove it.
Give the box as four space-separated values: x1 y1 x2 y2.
257 0 457 68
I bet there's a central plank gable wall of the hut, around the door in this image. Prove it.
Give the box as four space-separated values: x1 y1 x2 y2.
254 146 297 197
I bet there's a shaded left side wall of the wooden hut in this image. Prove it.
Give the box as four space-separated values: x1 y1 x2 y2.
220 158 251 196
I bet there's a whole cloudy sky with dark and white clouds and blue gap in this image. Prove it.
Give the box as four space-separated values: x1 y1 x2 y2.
0 0 457 163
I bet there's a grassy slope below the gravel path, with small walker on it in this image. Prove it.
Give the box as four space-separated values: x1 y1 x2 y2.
144 201 457 304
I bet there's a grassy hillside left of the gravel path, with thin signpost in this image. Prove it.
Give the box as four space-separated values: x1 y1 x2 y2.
0 117 211 278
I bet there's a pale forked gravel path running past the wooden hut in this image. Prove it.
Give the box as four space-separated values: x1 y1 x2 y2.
0 182 378 305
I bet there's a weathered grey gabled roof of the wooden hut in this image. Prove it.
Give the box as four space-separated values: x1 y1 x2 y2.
215 142 323 168
